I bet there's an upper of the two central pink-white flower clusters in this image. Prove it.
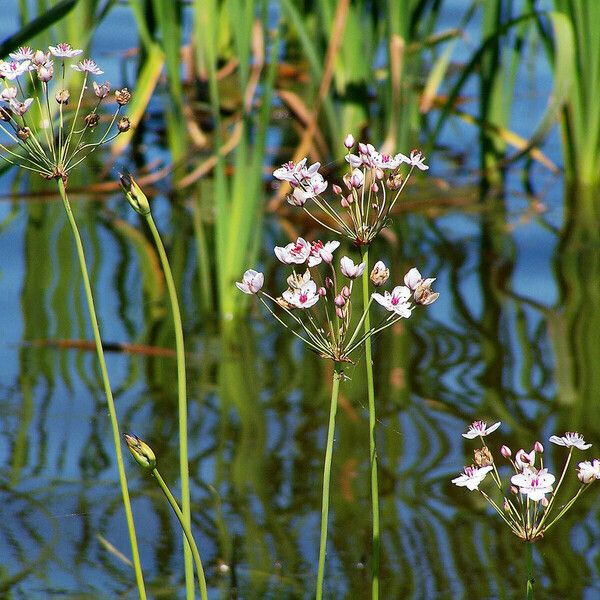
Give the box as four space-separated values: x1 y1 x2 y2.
273 134 429 246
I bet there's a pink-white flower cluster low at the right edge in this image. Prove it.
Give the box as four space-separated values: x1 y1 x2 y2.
452 421 600 541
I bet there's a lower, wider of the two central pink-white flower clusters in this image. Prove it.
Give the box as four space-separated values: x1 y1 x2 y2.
236 238 439 362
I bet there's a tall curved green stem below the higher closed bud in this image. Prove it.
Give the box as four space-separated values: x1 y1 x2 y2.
144 213 195 600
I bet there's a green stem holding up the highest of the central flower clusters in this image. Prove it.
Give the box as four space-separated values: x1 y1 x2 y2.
362 246 380 600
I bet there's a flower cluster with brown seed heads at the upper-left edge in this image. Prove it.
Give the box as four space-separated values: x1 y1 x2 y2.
0 43 131 181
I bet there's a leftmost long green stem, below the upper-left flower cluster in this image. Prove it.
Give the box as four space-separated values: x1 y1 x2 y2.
58 179 146 600
